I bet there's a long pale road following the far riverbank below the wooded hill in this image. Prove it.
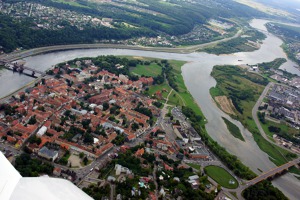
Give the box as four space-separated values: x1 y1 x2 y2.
0 29 243 62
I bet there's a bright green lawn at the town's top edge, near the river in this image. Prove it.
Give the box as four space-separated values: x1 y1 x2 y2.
131 63 161 77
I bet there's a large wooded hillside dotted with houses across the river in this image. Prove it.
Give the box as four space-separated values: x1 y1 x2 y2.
0 0 267 52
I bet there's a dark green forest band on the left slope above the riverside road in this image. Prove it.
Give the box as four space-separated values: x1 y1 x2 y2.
0 13 157 52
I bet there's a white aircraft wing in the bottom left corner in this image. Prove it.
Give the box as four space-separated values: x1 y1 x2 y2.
0 152 92 200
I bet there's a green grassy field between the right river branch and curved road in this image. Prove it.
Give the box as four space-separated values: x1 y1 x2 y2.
212 66 294 166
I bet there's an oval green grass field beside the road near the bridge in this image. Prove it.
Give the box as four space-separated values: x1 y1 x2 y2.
204 166 239 189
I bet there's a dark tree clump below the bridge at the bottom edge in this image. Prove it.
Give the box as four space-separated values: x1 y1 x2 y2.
243 181 288 200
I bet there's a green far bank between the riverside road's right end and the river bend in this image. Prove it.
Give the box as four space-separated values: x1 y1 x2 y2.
203 30 266 55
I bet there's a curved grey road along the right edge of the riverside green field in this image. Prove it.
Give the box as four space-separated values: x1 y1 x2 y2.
252 82 299 157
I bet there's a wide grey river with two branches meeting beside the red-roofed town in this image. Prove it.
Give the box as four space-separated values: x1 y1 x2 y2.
0 19 300 199
